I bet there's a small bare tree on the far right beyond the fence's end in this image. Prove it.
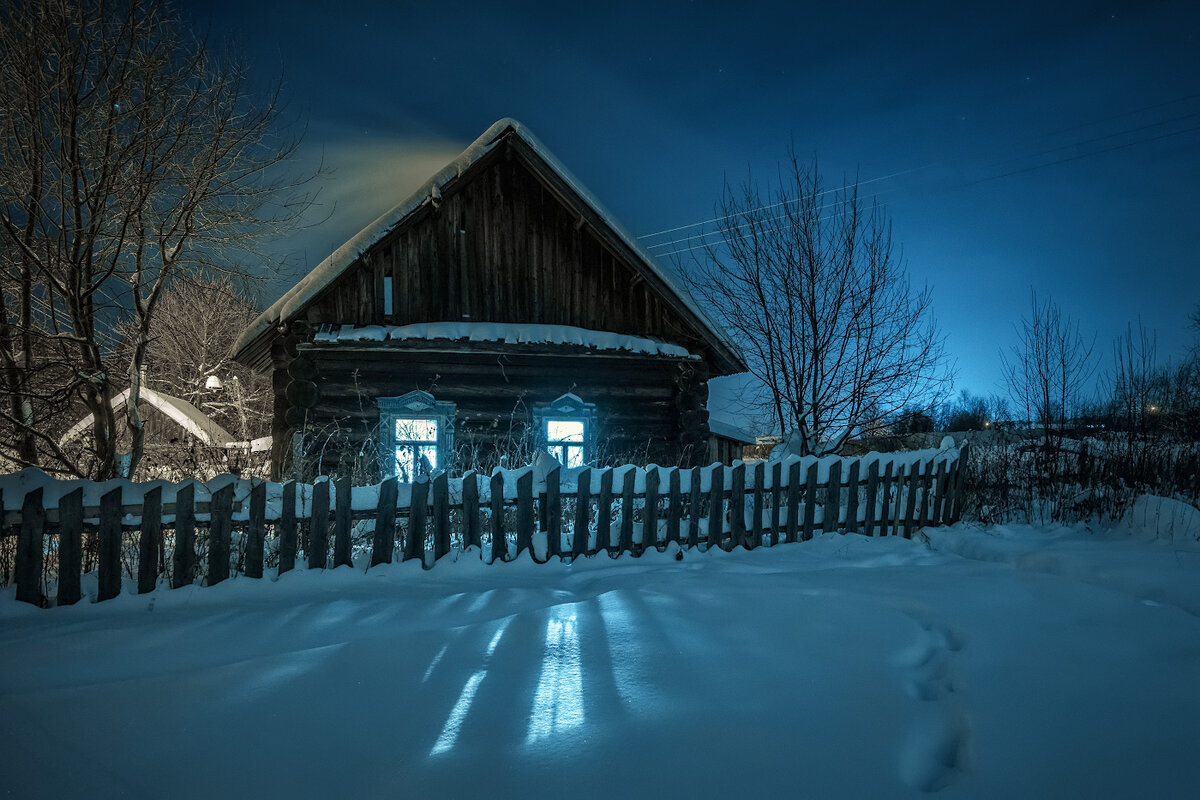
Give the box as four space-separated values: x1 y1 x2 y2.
1000 293 1096 450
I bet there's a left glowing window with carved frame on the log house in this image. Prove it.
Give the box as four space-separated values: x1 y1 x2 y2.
379 391 455 483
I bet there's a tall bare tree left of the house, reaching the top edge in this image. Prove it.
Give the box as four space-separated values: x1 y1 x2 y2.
0 0 306 479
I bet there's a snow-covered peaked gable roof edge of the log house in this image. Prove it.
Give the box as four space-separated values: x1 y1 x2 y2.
234 118 740 371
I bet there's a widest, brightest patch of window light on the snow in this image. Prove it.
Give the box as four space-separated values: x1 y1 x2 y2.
526 606 583 745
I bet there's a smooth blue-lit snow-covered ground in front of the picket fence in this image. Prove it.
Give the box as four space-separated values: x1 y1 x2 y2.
0 503 1200 798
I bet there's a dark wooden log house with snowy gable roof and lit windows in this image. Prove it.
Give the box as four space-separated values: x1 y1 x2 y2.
235 119 746 477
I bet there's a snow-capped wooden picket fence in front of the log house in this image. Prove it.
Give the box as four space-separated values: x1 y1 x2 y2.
0 447 966 606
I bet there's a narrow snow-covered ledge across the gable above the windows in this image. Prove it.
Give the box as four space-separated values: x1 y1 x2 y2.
314 323 695 359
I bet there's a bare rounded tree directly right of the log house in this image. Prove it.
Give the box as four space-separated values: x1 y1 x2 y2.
686 150 952 453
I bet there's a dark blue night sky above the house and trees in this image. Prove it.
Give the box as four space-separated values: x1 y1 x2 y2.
182 0 1200 395
